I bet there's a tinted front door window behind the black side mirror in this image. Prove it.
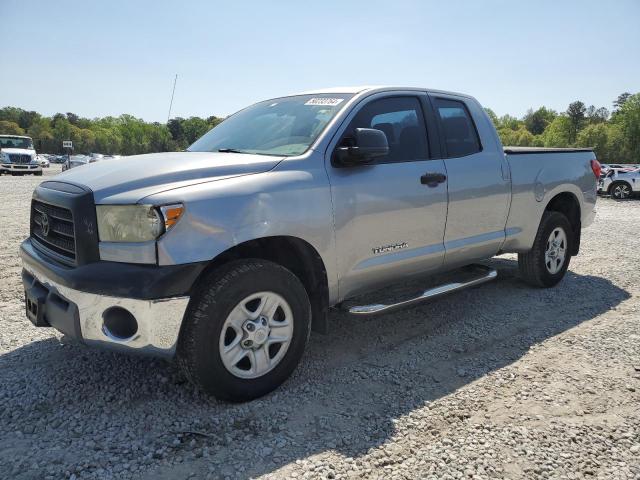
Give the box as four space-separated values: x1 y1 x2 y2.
341 97 429 163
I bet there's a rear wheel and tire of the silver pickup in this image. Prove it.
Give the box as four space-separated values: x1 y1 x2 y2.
518 211 575 288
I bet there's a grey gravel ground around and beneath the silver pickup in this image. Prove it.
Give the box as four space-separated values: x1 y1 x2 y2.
0 167 640 479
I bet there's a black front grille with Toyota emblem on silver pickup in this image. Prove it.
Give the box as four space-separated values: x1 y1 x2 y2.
31 200 76 262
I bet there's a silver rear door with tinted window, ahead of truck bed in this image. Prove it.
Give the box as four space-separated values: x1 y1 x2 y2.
430 94 511 267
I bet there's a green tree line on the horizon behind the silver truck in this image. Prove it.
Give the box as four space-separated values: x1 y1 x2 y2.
0 92 640 163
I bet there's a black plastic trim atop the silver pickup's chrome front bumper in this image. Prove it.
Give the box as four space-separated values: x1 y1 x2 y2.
20 239 208 300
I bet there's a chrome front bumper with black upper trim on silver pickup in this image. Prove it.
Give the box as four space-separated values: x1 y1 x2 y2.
20 240 204 358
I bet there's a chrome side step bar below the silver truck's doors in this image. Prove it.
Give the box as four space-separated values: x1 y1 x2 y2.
344 265 498 316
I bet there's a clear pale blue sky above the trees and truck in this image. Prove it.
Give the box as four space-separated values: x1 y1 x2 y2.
0 0 640 121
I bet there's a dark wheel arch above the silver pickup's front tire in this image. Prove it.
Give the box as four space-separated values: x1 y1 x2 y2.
192 235 329 333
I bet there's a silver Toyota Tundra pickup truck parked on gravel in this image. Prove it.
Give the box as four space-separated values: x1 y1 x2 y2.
20 87 600 401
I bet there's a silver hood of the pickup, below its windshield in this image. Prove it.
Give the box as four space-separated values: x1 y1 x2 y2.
55 152 284 204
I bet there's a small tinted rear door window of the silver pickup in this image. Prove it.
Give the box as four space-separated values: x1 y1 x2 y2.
435 98 482 158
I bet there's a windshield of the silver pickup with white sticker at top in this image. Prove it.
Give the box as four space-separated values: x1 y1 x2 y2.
187 94 353 156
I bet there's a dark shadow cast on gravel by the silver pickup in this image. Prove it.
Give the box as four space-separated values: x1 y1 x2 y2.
0 258 630 479
